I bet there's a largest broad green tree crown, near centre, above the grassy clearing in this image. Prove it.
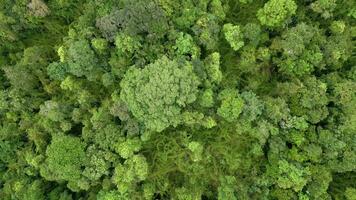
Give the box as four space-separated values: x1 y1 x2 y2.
120 57 199 132
